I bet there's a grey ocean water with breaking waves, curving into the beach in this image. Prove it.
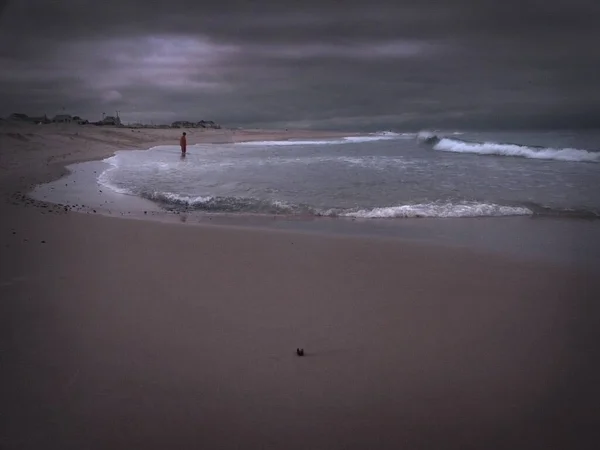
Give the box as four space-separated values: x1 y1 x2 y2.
98 131 600 219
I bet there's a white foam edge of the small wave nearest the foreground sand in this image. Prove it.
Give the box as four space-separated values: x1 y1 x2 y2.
336 202 533 219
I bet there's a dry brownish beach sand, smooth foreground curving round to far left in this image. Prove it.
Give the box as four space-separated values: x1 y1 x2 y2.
0 123 600 449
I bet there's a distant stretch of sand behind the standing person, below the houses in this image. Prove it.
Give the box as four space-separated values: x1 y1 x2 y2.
0 123 360 200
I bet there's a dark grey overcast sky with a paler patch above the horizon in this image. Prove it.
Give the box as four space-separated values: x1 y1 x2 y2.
0 0 600 130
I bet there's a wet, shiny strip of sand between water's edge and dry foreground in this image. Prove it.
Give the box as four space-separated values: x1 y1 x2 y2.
28 151 600 270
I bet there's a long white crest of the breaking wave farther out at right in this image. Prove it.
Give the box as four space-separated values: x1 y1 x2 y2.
433 138 600 162
